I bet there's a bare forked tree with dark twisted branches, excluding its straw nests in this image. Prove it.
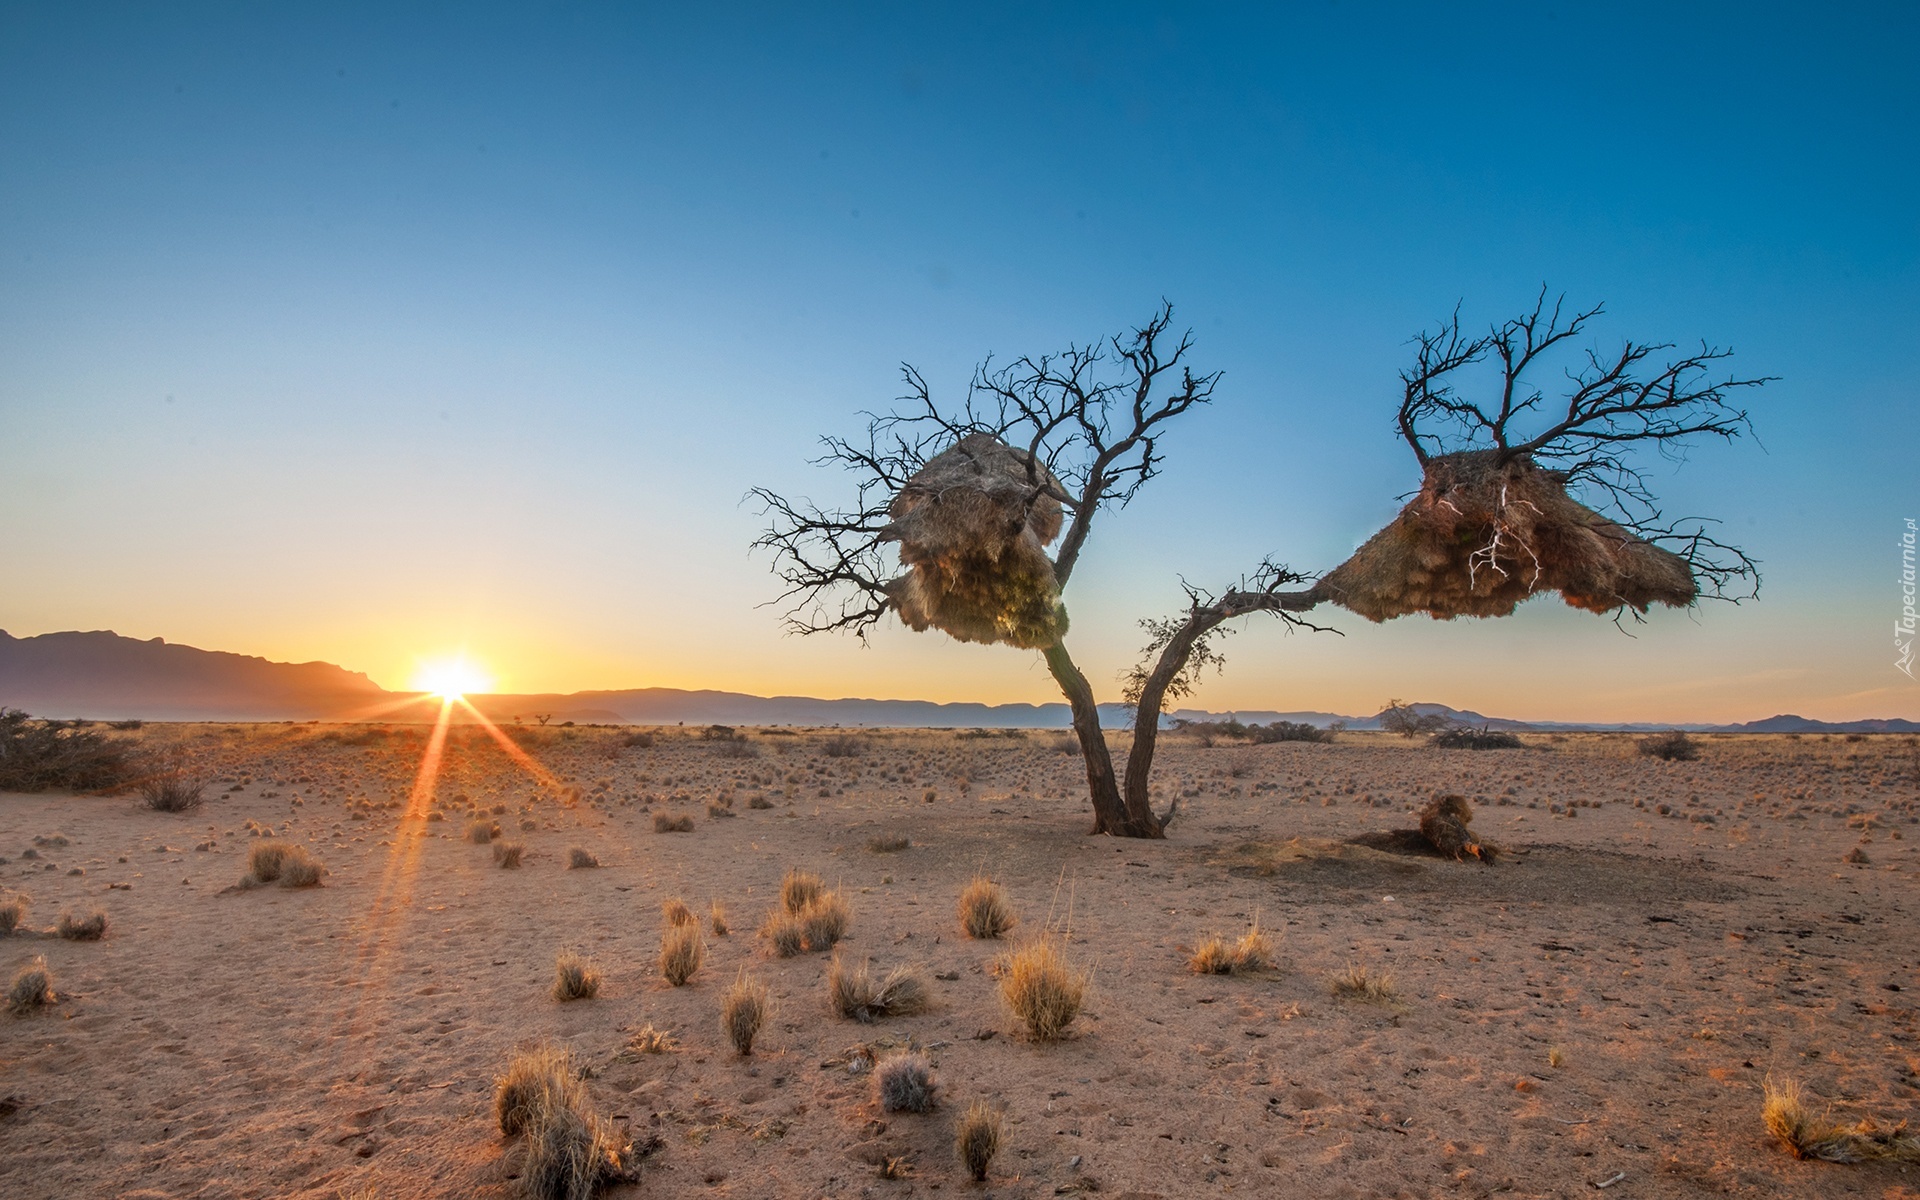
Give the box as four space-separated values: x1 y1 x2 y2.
753 298 1761 837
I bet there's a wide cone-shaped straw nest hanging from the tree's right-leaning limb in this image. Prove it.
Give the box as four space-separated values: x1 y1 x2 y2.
1313 449 1699 620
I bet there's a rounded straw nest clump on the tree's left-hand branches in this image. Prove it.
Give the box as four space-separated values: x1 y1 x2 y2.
883 434 1068 649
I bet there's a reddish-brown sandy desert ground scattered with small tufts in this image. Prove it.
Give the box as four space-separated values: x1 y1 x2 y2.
0 726 1920 1200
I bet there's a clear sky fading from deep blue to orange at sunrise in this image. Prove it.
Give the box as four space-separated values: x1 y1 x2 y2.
0 4 1920 720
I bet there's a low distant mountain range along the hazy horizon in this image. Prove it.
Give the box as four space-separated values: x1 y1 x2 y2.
0 632 1920 733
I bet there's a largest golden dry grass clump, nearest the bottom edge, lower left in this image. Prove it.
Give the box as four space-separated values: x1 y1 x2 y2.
493 1046 634 1200
